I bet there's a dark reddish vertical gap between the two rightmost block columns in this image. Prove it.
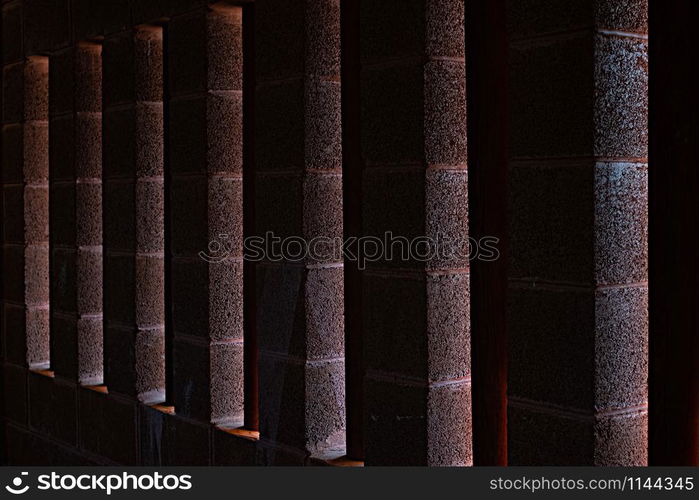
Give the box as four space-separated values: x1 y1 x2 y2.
466 0 509 466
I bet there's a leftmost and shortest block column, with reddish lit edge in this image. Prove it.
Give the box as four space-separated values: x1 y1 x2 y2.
2 52 49 369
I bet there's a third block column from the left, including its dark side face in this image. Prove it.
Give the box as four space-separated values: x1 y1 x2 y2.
103 26 165 402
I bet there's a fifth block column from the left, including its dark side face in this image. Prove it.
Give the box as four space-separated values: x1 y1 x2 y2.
255 0 346 463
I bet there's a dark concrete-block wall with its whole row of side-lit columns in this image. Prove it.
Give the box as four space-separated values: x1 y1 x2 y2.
2 0 676 465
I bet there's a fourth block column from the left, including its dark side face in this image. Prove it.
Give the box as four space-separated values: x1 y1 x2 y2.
168 4 243 426
